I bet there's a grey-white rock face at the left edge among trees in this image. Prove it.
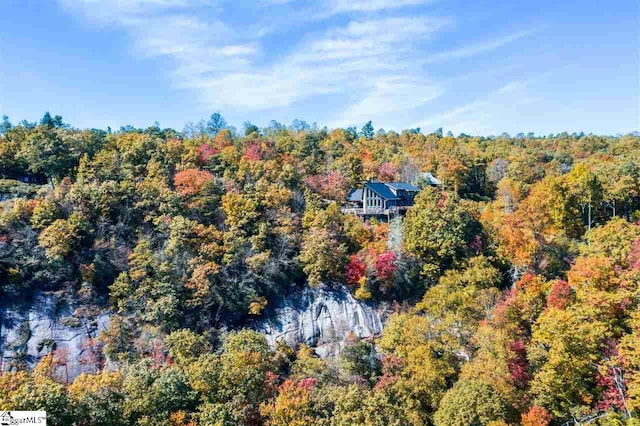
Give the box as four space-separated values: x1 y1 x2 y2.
0 294 109 380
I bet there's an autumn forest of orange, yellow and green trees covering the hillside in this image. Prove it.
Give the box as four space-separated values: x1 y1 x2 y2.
0 113 640 426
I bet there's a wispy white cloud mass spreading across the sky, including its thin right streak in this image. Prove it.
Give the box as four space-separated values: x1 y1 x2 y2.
58 0 530 125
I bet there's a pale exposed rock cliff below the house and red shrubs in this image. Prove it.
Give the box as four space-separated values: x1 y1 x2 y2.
256 287 387 357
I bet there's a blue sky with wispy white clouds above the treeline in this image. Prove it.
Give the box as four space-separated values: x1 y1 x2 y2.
0 0 640 135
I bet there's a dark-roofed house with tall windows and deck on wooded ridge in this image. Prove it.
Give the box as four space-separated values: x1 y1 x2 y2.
342 181 420 220
